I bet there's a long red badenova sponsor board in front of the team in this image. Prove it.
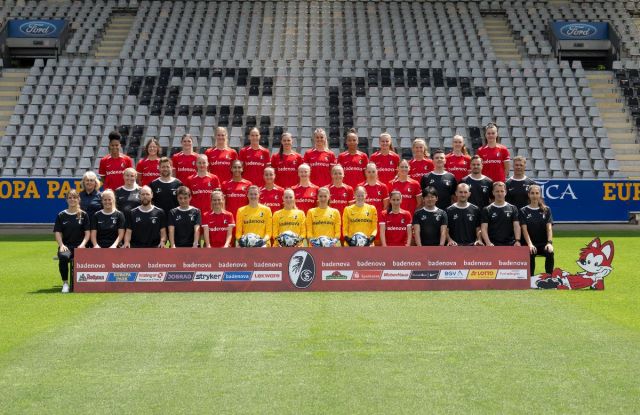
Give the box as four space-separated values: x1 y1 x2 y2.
74 246 530 292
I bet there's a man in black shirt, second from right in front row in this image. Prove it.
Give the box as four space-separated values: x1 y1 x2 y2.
480 182 521 246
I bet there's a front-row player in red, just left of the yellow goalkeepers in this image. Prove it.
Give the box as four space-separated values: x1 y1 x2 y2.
202 190 236 248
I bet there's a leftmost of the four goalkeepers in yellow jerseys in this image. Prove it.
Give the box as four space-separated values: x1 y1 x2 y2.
236 185 272 248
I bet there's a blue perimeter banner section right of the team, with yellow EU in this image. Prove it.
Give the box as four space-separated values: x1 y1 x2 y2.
538 180 640 222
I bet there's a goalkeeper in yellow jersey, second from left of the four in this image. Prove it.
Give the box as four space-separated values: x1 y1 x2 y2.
271 189 307 246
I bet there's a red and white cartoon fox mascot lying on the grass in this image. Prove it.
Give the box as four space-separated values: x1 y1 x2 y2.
531 238 613 290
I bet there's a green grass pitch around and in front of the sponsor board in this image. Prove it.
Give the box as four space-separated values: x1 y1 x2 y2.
0 232 640 414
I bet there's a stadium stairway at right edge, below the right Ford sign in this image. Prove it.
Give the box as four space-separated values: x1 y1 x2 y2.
585 71 640 178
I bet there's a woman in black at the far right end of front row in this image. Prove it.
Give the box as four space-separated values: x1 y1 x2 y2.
520 184 554 275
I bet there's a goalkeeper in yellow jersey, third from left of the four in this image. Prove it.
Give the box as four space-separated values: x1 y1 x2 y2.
307 187 340 247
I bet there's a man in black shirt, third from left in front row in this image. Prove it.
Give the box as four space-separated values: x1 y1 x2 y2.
124 186 167 248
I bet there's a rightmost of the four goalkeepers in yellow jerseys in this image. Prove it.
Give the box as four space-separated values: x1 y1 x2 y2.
342 186 378 246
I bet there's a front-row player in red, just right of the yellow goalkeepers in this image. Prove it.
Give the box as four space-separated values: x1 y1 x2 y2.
378 190 413 246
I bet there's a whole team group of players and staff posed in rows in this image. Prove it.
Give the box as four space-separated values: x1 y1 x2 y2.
54 124 554 292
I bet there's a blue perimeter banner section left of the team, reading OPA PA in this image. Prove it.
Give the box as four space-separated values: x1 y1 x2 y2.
0 177 82 224
